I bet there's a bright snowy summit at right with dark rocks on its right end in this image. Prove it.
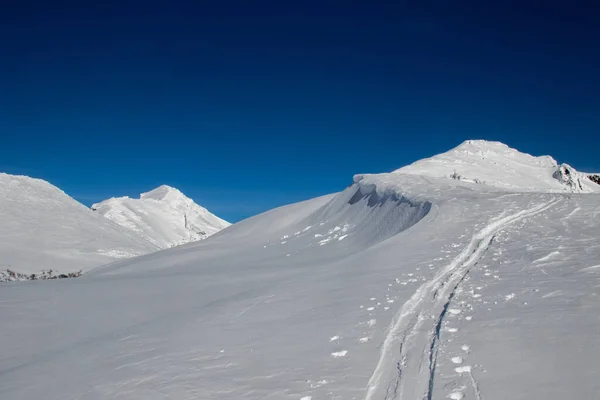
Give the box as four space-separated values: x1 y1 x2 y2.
394 140 600 193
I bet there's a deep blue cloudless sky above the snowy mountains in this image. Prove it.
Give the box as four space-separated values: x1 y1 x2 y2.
0 0 600 221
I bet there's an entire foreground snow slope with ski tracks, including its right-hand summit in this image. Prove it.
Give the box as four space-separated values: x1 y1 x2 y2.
0 142 600 400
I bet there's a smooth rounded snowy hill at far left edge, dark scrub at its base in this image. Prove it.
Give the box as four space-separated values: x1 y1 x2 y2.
0 173 158 273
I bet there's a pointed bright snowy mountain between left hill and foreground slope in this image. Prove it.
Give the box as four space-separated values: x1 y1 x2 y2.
92 185 230 248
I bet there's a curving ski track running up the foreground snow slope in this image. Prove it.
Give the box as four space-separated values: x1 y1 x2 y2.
365 198 560 400
